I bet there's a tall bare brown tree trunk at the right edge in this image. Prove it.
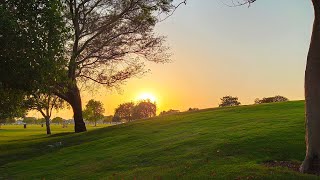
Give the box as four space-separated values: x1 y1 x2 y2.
300 0 320 174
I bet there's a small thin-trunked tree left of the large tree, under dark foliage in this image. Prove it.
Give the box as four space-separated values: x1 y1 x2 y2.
28 93 64 134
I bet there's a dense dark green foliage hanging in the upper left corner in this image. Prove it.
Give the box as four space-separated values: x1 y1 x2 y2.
0 0 65 92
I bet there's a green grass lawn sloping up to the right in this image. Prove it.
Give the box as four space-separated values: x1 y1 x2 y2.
0 101 317 179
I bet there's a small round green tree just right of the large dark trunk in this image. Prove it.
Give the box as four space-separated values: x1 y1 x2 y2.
83 99 104 126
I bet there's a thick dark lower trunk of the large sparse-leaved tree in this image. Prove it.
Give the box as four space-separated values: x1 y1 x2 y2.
68 86 87 133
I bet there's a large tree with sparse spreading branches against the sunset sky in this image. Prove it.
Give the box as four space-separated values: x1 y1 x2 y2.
55 0 185 132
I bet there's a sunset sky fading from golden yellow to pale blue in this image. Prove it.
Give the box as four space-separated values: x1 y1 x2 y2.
29 0 313 118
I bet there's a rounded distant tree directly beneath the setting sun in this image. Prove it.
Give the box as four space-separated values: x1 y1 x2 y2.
132 100 157 120
